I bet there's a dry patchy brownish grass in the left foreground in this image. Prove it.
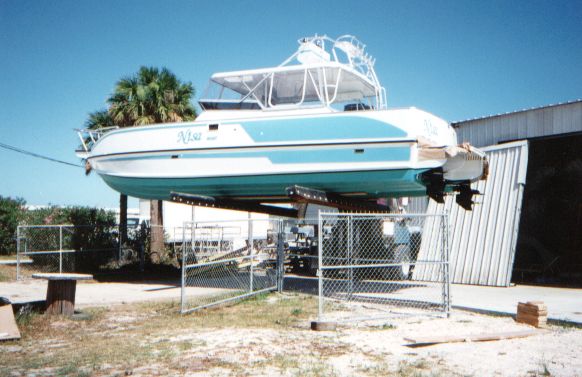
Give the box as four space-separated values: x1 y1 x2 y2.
0 294 322 376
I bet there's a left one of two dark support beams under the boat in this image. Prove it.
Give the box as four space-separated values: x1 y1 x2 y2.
170 192 297 218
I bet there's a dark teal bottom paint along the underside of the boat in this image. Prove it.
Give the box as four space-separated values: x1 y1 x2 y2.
101 169 426 200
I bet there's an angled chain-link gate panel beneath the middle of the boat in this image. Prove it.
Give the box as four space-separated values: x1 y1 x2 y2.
181 219 283 313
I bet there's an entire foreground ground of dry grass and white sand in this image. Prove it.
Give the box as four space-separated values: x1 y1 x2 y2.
0 294 582 376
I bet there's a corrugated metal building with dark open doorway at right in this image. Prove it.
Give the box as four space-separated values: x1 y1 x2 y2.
415 100 582 286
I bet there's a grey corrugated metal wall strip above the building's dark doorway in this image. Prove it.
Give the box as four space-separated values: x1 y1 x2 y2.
454 101 582 147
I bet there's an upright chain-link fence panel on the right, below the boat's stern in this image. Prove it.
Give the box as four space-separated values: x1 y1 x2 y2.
318 213 450 322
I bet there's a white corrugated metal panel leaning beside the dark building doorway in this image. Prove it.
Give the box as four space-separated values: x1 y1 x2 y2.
413 142 528 286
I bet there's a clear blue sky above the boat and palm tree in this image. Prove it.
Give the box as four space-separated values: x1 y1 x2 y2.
0 0 582 207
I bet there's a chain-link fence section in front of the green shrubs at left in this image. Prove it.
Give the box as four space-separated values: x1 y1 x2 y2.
16 225 121 279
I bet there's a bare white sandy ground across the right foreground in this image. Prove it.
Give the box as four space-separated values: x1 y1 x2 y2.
81 303 582 377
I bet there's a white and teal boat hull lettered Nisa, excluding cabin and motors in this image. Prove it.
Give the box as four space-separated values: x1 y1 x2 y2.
81 108 484 202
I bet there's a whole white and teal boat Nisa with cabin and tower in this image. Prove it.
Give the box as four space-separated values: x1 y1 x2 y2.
77 35 487 209
